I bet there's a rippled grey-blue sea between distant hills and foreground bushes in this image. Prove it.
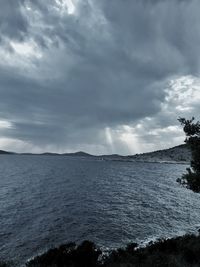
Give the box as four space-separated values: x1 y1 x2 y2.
0 155 200 265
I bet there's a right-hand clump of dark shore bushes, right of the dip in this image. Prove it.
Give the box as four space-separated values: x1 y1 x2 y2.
103 235 200 267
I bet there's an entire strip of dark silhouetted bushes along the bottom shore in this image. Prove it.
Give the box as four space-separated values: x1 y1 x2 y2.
9 235 197 267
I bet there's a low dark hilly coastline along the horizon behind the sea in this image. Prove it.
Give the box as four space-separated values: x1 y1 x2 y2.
0 144 191 163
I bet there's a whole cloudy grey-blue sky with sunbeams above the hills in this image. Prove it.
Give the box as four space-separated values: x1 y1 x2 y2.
0 0 200 155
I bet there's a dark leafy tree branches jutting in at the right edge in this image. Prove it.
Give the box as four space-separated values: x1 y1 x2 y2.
177 118 200 192
